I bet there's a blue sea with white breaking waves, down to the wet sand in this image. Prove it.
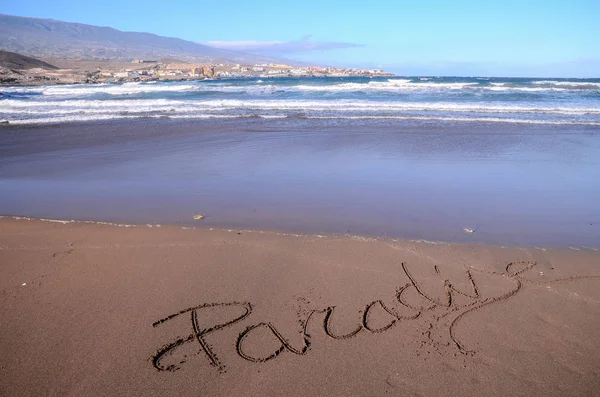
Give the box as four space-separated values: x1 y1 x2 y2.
0 77 600 126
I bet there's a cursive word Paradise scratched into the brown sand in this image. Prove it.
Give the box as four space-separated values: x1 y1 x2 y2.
152 262 596 372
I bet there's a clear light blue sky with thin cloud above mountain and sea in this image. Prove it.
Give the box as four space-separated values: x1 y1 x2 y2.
0 0 600 77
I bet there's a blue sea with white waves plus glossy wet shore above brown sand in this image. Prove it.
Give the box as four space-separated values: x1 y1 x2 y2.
0 77 600 249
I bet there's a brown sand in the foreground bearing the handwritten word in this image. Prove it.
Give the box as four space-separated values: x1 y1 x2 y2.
0 218 600 396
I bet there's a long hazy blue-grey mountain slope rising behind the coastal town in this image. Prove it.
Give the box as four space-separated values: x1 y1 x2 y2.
0 14 290 64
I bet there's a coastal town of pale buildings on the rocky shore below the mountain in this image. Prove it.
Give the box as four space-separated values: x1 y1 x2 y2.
0 53 392 85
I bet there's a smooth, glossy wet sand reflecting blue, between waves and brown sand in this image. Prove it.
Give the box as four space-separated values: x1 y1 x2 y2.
0 118 600 248
